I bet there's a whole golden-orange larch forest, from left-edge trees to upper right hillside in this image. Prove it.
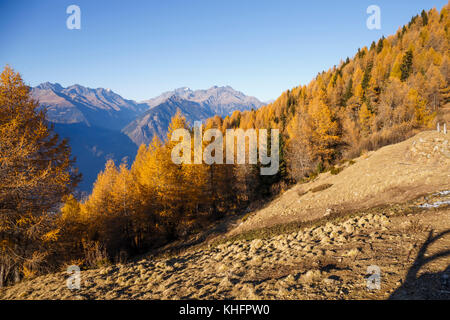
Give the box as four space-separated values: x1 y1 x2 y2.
0 5 450 285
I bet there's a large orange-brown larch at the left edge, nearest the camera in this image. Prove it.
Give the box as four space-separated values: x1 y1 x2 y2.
0 66 79 285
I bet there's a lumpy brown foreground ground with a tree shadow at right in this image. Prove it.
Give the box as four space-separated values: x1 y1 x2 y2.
0 192 450 300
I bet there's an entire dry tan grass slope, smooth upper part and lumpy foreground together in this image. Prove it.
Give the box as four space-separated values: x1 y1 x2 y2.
0 132 450 299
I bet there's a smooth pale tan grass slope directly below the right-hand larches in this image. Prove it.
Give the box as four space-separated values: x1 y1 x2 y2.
228 128 450 235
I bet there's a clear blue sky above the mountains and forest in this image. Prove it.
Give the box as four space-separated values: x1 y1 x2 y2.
0 0 447 101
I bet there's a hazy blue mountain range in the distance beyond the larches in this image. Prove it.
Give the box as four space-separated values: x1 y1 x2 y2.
31 82 264 191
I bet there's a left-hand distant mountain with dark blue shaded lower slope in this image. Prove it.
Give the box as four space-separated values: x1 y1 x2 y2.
31 82 148 192
